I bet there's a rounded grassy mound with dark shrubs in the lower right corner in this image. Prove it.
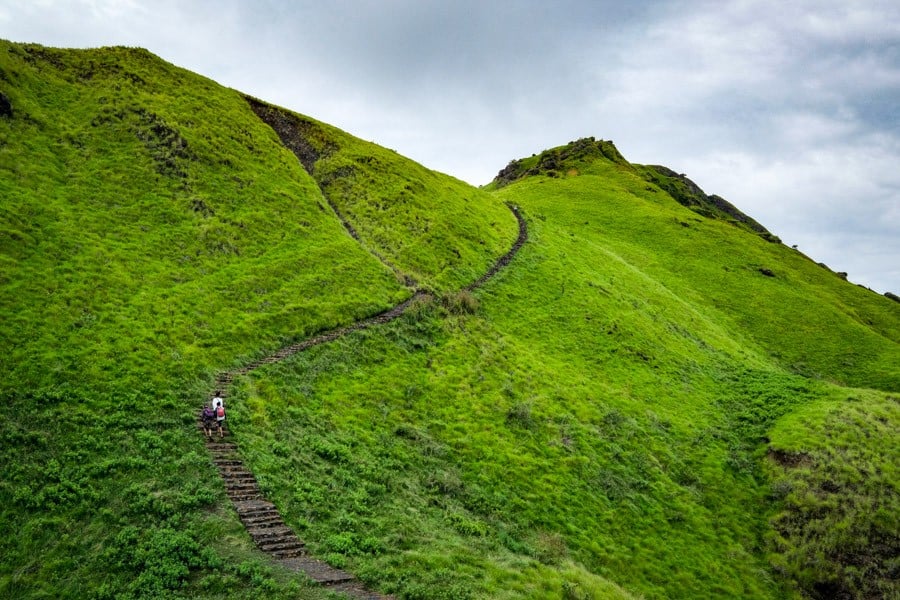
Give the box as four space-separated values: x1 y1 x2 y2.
769 394 900 600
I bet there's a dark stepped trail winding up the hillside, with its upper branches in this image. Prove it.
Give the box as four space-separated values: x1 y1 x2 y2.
198 99 528 600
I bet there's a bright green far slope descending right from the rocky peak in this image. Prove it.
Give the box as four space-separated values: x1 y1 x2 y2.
497 142 900 392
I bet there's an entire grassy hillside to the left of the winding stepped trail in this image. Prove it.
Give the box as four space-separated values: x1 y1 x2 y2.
0 42 516 598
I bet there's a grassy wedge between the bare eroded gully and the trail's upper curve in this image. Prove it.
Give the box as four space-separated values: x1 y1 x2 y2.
248 98 515 292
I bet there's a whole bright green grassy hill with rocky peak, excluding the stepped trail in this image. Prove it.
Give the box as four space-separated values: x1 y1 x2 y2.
0 42 900 599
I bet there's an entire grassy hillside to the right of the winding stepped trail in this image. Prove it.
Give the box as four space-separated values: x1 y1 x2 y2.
229 142 900 598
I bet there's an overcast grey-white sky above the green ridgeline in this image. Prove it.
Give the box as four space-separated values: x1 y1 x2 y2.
0 0 900 293
